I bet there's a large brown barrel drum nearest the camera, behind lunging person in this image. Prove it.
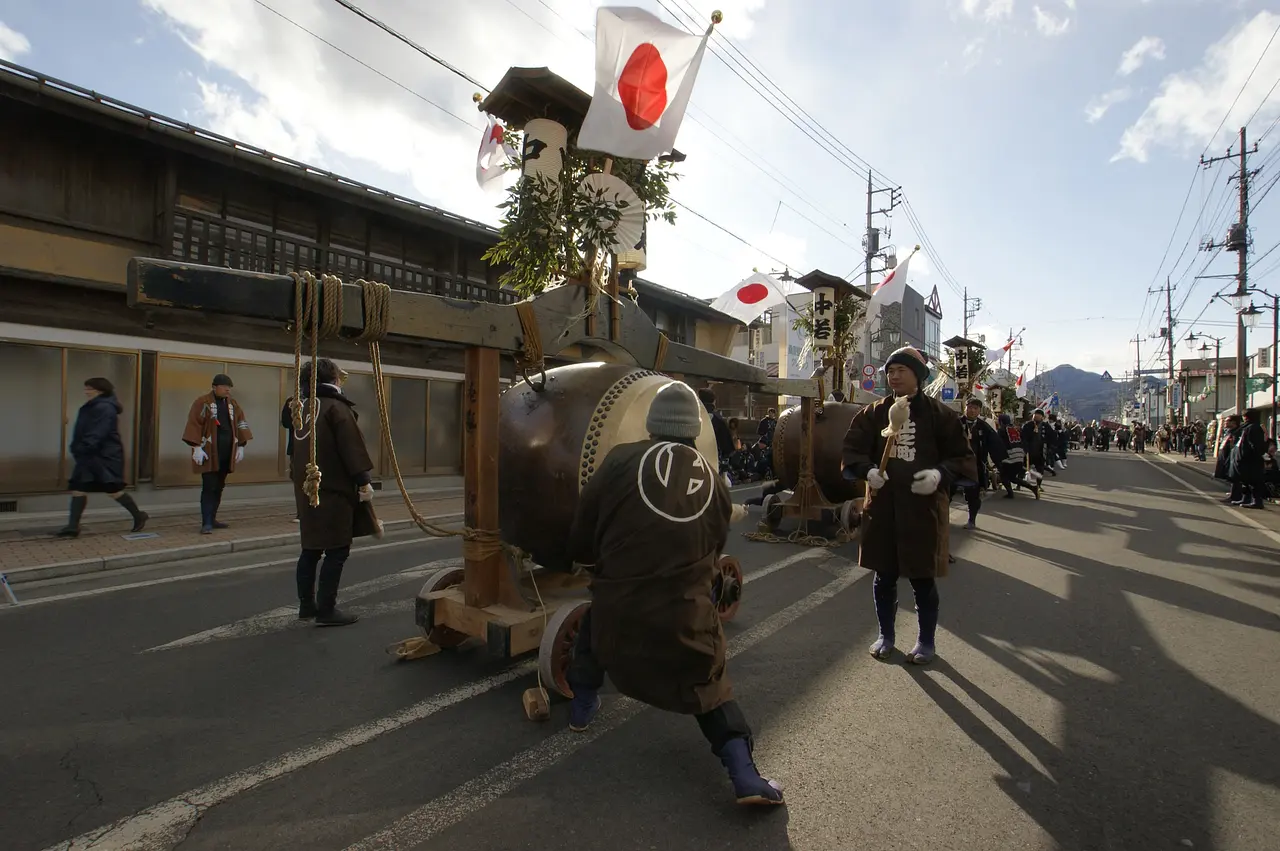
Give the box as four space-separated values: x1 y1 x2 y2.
498 362 719 571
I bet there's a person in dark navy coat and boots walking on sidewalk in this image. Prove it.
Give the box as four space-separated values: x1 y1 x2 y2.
58 379 147 537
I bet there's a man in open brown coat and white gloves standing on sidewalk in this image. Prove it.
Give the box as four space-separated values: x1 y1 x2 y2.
182 372 253 535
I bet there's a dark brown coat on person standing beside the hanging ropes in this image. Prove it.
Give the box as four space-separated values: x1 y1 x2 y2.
291 384 374 549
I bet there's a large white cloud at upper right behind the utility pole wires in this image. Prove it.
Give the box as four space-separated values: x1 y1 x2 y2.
1111 12 1280 163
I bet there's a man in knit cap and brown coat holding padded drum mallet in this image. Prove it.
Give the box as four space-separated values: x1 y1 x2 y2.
842 346 978 664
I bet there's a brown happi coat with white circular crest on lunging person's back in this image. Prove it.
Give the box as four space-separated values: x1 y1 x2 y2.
571 440 733 714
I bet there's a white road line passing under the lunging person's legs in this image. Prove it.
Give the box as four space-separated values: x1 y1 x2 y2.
347 557 870 851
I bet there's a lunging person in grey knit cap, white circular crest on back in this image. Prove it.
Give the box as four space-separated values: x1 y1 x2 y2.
568 381 782 804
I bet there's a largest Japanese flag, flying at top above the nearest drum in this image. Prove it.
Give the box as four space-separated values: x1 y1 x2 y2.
577 6 712 160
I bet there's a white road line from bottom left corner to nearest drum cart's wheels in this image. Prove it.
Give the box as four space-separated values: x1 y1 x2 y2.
45 548 835 851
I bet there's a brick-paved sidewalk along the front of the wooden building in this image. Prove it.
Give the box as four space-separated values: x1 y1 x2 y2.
0 490 462 583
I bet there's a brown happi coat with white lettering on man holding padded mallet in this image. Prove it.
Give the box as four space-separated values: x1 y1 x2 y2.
844 393 978 578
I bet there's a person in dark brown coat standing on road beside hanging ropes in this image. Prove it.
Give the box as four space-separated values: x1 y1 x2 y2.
291 357 380 627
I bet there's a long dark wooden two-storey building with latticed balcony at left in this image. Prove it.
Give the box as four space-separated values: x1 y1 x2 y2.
0 64 736 511
